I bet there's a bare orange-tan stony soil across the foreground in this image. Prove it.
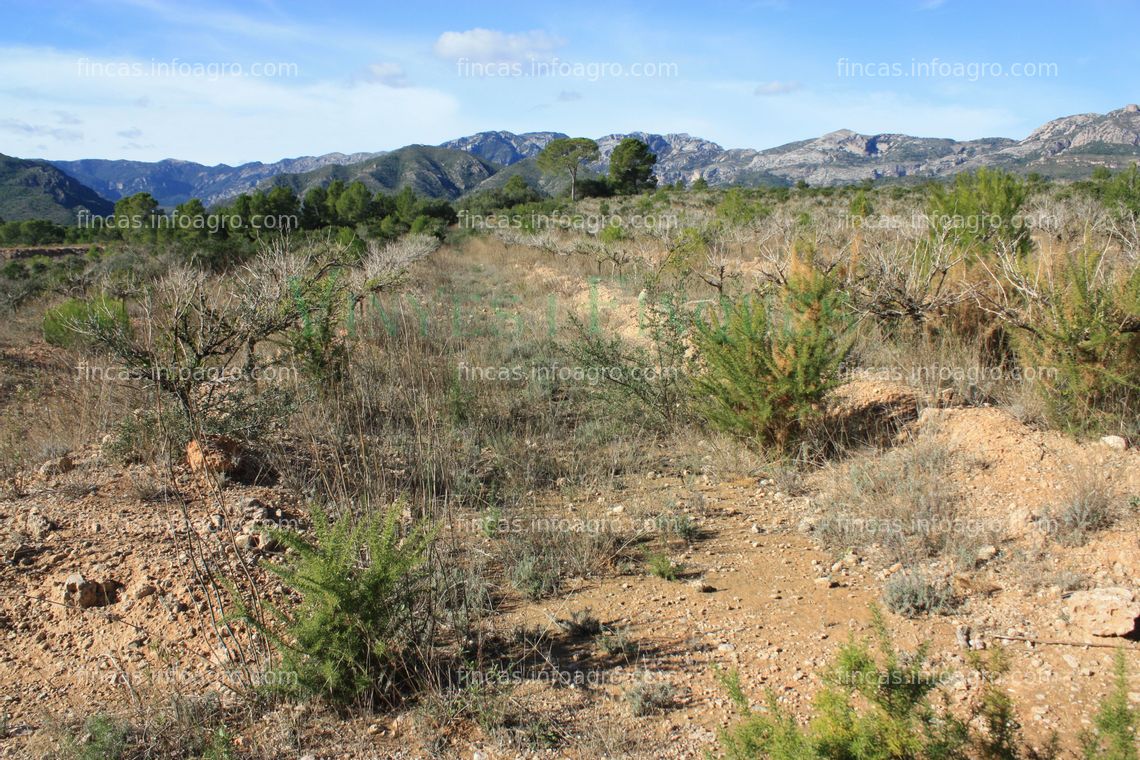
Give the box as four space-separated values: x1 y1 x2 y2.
0 387 1140 758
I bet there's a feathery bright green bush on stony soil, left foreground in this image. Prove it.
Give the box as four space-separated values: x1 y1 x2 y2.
243 505 431 706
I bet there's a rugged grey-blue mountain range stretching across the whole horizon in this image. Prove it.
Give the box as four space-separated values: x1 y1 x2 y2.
0 105 1140 221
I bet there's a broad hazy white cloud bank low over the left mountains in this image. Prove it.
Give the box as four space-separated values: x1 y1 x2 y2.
0 47 467 164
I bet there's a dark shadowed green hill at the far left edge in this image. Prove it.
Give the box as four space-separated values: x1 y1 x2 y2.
0 154 114 224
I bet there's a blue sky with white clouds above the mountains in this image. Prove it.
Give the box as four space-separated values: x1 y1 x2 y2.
0 0 1140 165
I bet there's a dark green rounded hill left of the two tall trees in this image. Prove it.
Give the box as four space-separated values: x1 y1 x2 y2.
262 145 502 199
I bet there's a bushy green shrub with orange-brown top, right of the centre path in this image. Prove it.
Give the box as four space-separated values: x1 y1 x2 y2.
693 264 850 451
